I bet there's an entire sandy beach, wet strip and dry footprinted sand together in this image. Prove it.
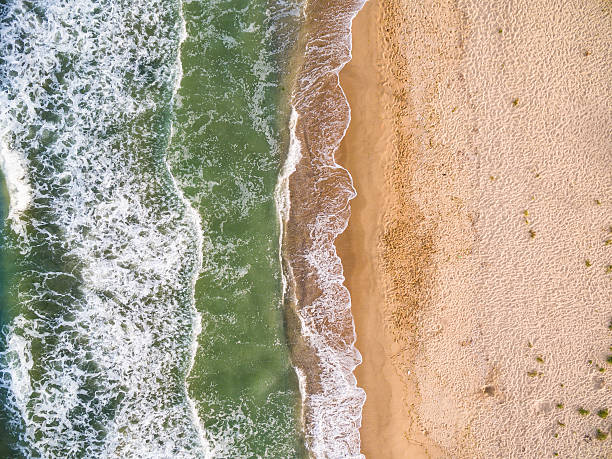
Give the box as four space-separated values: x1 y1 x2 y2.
338 0 612 458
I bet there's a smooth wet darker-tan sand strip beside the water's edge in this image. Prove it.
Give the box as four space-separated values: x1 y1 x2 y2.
336 0 435 459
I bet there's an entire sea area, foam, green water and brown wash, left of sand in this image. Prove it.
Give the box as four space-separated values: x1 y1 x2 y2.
0 0 364 458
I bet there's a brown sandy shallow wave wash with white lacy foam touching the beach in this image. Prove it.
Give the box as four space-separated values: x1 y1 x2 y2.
277 0 365 458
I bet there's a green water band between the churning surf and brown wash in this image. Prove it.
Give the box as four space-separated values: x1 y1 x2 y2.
168 0 305 458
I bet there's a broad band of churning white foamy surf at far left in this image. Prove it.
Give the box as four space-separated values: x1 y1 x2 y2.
0 0 209 458
